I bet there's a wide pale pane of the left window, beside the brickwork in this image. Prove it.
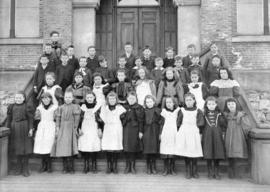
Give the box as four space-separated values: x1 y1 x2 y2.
15 0 39 37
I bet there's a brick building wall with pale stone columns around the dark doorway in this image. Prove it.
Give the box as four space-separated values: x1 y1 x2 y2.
0 0 270 69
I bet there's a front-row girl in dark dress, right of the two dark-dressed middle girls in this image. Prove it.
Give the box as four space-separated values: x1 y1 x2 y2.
140 95 163 174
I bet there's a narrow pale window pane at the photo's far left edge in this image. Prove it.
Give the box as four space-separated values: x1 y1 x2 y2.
0 0 10 38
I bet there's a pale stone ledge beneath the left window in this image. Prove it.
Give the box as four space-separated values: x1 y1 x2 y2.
0 38 44 45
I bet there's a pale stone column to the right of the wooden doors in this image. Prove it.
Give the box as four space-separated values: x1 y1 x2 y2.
174 0 201 56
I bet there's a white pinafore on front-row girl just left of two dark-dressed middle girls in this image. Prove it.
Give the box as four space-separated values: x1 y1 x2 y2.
100 105 126 151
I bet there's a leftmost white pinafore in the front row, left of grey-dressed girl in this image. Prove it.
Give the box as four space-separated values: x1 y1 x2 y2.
34 105 57 154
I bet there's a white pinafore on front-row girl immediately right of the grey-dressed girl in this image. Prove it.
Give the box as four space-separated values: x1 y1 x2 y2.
78 104 101 152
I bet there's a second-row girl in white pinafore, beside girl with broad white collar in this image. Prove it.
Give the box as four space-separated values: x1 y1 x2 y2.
186 70 208 111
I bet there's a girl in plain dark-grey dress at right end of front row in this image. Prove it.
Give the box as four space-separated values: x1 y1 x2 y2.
224 98 250 178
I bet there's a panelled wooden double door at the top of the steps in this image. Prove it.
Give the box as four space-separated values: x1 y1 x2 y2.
116 7 160 55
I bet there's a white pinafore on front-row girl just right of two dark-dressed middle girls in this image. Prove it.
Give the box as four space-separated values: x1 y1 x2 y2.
160 107 180 155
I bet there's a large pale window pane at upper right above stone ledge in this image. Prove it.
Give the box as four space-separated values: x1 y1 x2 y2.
237 0 264 35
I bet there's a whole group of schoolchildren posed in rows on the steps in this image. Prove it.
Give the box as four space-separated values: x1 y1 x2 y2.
7 32 249 179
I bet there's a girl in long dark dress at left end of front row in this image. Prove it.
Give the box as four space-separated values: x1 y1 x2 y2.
7 92 33 177
